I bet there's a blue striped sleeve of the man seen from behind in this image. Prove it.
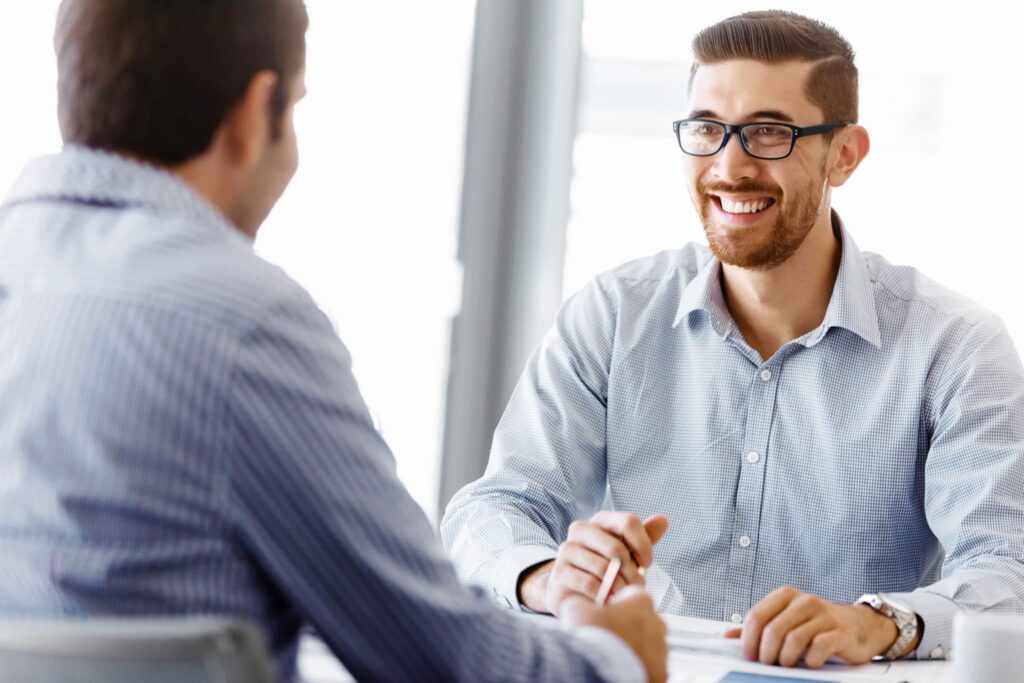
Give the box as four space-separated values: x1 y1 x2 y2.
225 298 644 681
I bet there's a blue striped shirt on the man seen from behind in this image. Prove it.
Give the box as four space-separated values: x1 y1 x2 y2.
0 147 642 681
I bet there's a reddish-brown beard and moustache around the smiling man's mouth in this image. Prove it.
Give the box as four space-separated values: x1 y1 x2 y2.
696 175 824 270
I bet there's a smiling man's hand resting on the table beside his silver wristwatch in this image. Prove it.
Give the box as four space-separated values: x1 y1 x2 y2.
725 587 918 669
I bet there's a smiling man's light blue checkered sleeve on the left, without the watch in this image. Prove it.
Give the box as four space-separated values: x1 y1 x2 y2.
441 280 615 607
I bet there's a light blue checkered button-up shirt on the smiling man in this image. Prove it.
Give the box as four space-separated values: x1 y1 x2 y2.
441 217 1024 657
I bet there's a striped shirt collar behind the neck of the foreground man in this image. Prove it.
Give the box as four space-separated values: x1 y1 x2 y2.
2 144 241 242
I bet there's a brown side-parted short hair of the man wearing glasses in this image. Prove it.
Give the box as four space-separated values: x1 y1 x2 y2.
690 10 857 123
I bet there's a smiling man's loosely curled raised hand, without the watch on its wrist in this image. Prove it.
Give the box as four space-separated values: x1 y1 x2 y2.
519 511 669 614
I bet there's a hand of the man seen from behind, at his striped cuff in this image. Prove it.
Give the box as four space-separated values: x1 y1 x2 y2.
561 587 669 683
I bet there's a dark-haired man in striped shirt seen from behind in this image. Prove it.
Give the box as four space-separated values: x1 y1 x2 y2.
0 0 667 681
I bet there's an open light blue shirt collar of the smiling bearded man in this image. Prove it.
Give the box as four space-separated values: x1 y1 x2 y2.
672 211 882 348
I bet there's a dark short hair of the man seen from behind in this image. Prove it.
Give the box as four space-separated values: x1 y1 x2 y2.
54 0 308 165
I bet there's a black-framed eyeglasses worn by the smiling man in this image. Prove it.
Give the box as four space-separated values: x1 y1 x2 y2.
672 119 851 160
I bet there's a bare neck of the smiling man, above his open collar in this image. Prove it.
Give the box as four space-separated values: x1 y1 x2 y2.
722 211 842 360
